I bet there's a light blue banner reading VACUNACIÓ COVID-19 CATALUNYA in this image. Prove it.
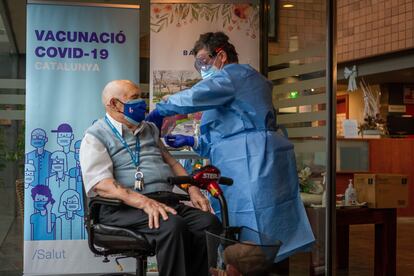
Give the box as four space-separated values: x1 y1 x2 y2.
24 1 139 275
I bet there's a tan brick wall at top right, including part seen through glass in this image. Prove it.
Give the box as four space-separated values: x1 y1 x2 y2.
269 0 414 62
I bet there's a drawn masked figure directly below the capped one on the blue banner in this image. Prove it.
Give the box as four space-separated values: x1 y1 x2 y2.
47 151 69 212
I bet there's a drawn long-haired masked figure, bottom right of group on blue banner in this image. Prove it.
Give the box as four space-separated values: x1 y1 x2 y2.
56 189 86 240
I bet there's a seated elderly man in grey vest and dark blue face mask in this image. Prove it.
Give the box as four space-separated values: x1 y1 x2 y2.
80 80 221 276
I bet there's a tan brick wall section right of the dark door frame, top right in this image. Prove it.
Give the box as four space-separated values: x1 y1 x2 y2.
337 0 414 62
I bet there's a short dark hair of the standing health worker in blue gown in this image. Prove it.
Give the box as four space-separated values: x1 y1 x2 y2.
193 32 239 63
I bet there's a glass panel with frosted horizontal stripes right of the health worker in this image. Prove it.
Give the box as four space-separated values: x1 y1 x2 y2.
261 0 336 275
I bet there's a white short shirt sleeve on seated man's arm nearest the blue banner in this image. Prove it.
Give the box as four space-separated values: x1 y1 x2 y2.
79 134 113 197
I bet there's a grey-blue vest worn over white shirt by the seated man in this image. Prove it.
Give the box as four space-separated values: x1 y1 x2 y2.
86 119 173 194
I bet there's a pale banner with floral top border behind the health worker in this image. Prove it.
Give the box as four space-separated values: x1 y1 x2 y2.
150 1 260 135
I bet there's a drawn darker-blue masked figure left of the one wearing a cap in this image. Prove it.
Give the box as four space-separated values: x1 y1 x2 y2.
26 128 51 186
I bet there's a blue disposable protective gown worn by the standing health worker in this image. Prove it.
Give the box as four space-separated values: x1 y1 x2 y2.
157 64 314 261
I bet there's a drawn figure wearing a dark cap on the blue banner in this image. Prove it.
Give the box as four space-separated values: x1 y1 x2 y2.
52 123 76 172
